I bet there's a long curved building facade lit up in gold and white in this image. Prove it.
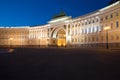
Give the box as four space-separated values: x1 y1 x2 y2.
0 1 120 48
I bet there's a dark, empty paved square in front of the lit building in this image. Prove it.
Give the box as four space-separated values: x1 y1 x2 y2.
0 48 120 80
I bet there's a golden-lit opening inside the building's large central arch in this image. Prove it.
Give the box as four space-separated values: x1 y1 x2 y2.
56 29 66 47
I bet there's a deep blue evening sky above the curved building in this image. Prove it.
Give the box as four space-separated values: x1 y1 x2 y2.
0 0 110 26
